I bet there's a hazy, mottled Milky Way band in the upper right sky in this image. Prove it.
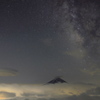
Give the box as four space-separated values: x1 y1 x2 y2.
52 0 100 74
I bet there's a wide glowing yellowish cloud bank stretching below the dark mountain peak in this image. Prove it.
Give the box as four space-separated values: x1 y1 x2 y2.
0 82 100 100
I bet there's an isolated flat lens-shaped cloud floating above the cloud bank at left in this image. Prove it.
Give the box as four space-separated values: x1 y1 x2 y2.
0 68 18 76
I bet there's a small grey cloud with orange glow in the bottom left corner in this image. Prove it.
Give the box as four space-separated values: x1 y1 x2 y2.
0 91 16 99
